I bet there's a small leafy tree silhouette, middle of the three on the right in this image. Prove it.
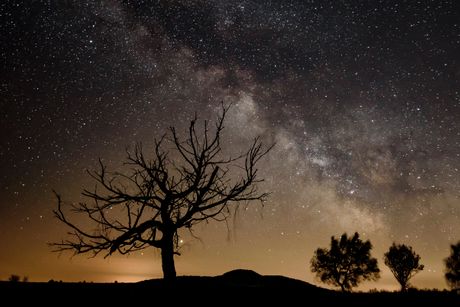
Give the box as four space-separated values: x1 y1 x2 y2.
383 243 424 291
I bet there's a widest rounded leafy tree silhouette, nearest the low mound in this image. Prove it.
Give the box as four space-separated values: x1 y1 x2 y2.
311 232 380 291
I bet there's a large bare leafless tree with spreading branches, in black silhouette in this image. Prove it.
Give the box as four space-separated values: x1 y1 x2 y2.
51 106 273 280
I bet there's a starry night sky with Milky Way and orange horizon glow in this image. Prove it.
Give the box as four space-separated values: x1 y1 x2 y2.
0 0 460 289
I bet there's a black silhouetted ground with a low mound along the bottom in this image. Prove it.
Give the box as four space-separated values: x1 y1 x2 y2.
0 270 460 307
